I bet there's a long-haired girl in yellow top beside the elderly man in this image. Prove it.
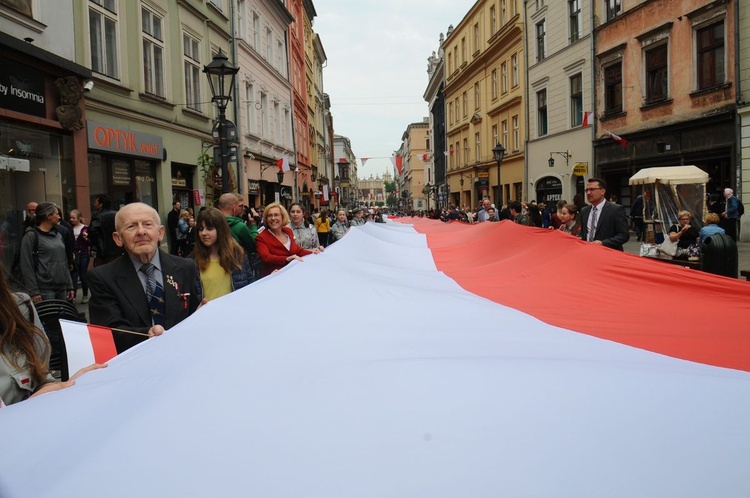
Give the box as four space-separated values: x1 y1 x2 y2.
195 208 254 301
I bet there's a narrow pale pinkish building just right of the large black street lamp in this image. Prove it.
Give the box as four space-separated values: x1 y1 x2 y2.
236 0 295 207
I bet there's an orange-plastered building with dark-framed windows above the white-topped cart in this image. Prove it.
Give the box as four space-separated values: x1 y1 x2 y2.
594 0 740 212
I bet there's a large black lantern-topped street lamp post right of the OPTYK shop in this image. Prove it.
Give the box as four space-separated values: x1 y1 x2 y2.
203 50 240 194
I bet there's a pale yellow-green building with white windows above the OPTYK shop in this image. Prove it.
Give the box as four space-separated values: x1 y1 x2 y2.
74 0 232 222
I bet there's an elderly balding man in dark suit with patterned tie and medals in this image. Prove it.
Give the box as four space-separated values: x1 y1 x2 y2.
89 202 203 351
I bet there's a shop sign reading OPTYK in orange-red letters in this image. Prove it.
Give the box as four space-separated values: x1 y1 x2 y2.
86 120 164 161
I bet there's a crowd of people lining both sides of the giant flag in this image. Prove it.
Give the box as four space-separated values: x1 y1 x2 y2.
0 178 741 406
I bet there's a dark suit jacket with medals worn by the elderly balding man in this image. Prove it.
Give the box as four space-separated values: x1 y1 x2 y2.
88 251 203 352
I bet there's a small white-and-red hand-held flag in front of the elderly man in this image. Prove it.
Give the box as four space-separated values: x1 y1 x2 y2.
60 320 123 375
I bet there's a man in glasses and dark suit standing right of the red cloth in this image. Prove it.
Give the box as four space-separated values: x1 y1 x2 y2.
580 178 630 251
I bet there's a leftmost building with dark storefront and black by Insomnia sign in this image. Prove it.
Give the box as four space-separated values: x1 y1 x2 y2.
0 1 91 268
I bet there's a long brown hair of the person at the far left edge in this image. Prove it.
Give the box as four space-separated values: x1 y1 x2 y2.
0 270 50 384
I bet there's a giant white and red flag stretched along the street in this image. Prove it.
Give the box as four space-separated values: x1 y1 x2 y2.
0 223 750 498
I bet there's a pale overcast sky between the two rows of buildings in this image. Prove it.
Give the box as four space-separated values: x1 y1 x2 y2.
313 0 475 179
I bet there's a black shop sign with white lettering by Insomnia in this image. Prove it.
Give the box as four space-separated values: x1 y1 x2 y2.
0 57 47 118
